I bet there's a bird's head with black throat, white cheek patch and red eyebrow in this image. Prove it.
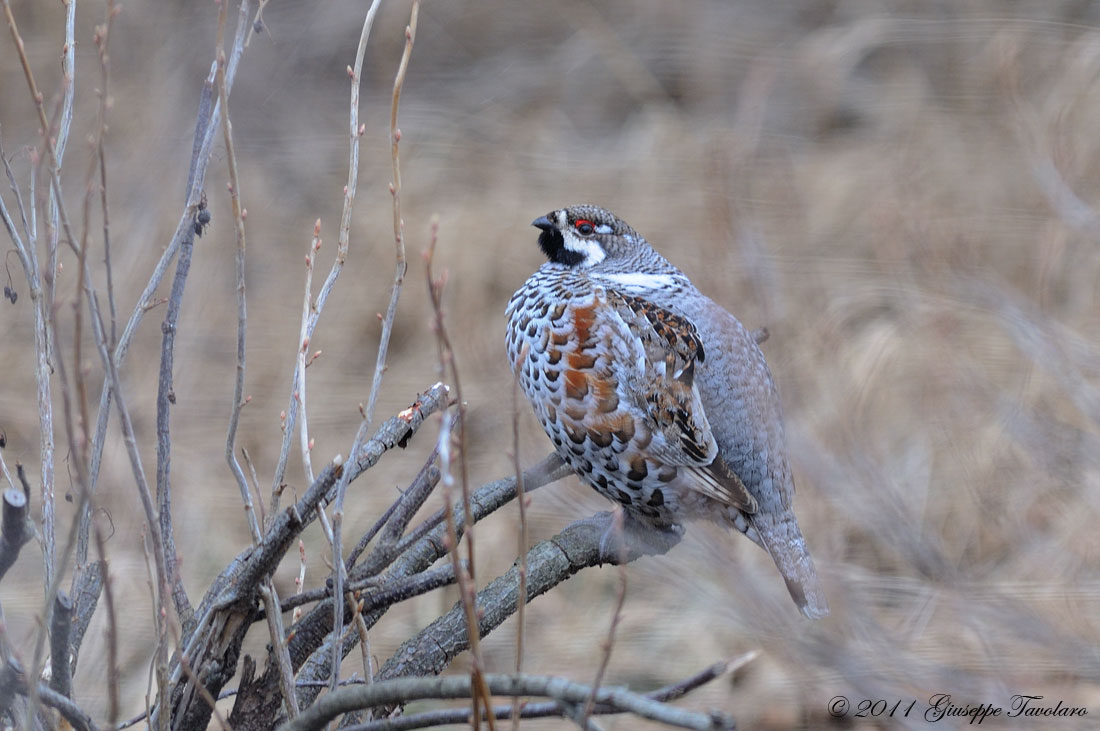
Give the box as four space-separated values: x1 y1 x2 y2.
531 206 648 268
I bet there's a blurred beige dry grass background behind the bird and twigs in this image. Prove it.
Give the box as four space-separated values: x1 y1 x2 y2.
0 0 1100 729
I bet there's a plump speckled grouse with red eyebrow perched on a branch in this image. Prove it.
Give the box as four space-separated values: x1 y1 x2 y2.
506 204 829 619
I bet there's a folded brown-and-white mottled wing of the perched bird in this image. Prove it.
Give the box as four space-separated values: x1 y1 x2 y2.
606 289 758 513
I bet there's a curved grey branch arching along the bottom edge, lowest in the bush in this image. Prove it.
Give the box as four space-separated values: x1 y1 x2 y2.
279 674 734 731
